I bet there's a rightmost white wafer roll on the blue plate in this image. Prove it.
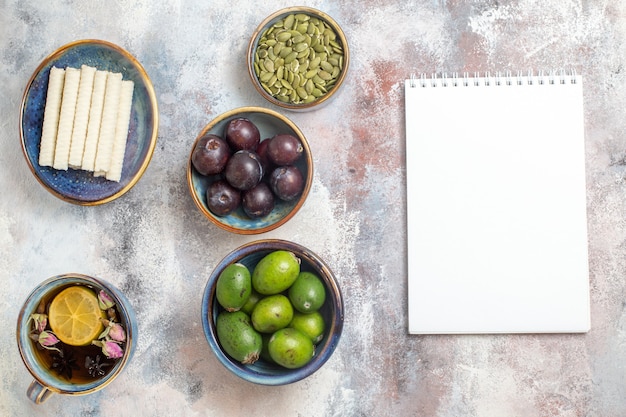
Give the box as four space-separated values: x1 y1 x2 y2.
106 80 135 182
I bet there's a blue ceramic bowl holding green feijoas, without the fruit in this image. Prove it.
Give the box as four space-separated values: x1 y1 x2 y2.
202 239 344 385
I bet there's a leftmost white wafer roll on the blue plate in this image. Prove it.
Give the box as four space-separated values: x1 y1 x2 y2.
39 67 65 167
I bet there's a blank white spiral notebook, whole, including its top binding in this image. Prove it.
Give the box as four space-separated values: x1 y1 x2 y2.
405 73 590 334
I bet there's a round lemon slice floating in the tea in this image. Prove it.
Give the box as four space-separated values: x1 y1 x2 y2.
48 286 106 346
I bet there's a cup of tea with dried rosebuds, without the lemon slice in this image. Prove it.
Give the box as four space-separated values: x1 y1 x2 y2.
17 273 137 404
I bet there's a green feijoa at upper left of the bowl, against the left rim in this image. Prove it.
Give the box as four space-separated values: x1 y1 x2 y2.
215 263 252 312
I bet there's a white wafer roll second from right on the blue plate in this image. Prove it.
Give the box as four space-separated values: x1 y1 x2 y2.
94 73 122 172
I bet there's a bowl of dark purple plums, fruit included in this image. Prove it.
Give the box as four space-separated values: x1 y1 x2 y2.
187 107 313 234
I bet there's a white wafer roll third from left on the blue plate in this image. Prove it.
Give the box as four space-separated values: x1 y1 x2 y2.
68 65 96 169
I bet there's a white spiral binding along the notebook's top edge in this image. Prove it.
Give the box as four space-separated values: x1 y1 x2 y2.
409 69 578 88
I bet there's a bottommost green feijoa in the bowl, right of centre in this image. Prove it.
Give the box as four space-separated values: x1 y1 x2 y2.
268 327 315 369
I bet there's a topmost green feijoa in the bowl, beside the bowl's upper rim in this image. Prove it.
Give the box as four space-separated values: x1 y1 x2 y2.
252 250 300 295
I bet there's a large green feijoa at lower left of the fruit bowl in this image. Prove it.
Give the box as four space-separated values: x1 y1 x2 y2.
215 311 263 364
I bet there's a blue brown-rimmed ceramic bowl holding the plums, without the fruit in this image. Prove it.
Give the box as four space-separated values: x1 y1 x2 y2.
187 107 313 234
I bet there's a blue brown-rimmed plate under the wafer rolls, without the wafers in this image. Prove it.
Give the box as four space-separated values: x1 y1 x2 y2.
20 40 159 206
